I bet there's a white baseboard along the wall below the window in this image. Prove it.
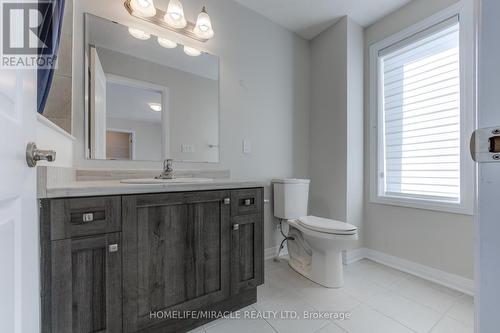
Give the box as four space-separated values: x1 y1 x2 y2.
360 248 474 296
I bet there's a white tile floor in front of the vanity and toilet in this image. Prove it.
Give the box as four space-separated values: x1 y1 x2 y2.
188 260 474 333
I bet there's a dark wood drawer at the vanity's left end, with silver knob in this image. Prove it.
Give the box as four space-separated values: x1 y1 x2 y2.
50 197 121 240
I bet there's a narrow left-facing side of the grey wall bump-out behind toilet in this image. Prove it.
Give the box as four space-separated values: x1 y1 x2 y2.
309 17 348 221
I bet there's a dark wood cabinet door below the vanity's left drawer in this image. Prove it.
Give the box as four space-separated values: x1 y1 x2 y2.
50 233 122 333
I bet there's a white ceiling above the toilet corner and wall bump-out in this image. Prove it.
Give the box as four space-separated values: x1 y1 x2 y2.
235 0 411 39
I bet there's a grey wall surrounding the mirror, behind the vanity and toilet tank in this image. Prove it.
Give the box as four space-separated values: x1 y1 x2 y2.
73 0 310 247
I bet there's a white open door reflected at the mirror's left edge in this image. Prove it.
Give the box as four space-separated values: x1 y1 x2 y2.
90 47 106 160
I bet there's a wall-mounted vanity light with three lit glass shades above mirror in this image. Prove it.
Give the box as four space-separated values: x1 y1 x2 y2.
124 0 214 42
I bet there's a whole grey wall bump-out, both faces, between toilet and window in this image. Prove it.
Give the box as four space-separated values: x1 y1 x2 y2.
309 16 363 239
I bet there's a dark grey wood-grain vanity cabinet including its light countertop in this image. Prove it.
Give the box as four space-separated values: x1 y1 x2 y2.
40 172 264 333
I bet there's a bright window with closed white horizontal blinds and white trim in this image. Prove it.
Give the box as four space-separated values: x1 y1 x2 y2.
370 5 473 213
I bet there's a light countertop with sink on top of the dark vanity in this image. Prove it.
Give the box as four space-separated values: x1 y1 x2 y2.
39 178 269 199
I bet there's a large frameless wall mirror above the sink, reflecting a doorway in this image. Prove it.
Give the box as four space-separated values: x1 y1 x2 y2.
85 14 219 162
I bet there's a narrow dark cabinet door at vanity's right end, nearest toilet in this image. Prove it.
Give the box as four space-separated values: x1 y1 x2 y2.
231 213 264 295
